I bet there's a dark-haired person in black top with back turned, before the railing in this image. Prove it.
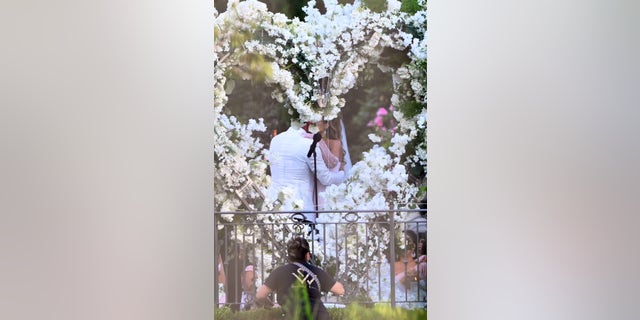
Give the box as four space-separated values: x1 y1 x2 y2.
256 237 344 320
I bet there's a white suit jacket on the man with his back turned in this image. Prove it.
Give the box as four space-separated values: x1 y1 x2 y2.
268 127 345 221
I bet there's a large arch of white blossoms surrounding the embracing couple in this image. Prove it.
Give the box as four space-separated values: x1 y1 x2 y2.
214 0 427 211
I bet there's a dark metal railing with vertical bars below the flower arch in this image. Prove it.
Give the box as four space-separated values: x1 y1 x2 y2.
214 209 427 310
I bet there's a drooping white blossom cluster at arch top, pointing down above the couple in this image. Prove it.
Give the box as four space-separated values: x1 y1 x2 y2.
216 0 411 122
